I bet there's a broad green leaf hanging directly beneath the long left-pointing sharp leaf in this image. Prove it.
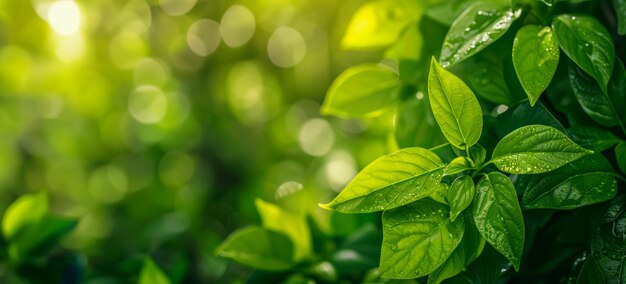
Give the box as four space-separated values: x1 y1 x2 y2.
380 199 464 279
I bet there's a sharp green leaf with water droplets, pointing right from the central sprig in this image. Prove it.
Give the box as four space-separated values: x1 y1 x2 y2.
491 125 593 174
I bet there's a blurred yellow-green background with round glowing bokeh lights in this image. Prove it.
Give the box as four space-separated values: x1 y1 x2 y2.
0 0 393 283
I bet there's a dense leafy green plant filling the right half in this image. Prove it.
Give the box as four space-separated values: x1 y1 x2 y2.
320 0 626 283
